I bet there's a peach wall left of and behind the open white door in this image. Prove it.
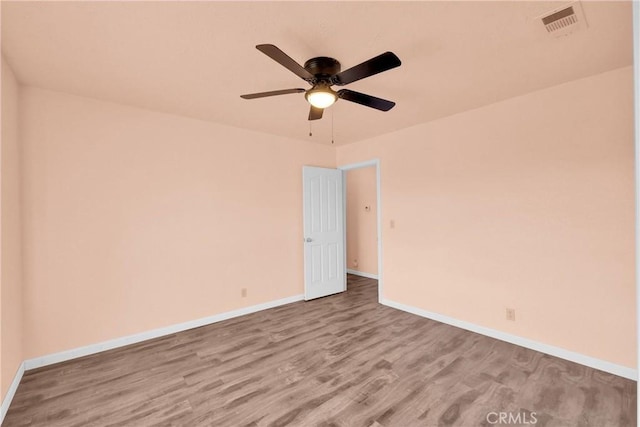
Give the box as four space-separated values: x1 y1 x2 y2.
20 88 335 358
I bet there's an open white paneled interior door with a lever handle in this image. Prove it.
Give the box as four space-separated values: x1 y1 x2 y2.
302 166 347 300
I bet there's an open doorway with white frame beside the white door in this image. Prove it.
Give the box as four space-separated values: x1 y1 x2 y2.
338 159 382 301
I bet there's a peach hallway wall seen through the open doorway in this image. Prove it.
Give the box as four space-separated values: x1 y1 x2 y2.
346 167 378 275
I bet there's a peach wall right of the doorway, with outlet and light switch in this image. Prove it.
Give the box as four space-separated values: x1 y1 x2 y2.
337 67 636 368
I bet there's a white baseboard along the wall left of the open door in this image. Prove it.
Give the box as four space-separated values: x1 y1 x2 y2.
24 295 303 370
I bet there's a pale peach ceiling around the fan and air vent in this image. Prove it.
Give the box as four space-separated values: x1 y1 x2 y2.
1 1 633 144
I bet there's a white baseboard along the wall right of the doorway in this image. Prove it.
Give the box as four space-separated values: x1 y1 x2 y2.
380 298 638 381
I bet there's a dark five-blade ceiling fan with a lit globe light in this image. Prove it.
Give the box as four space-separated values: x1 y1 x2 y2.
240 44 401 120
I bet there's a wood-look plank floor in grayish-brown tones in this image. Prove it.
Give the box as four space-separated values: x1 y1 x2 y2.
3 276 636 427
